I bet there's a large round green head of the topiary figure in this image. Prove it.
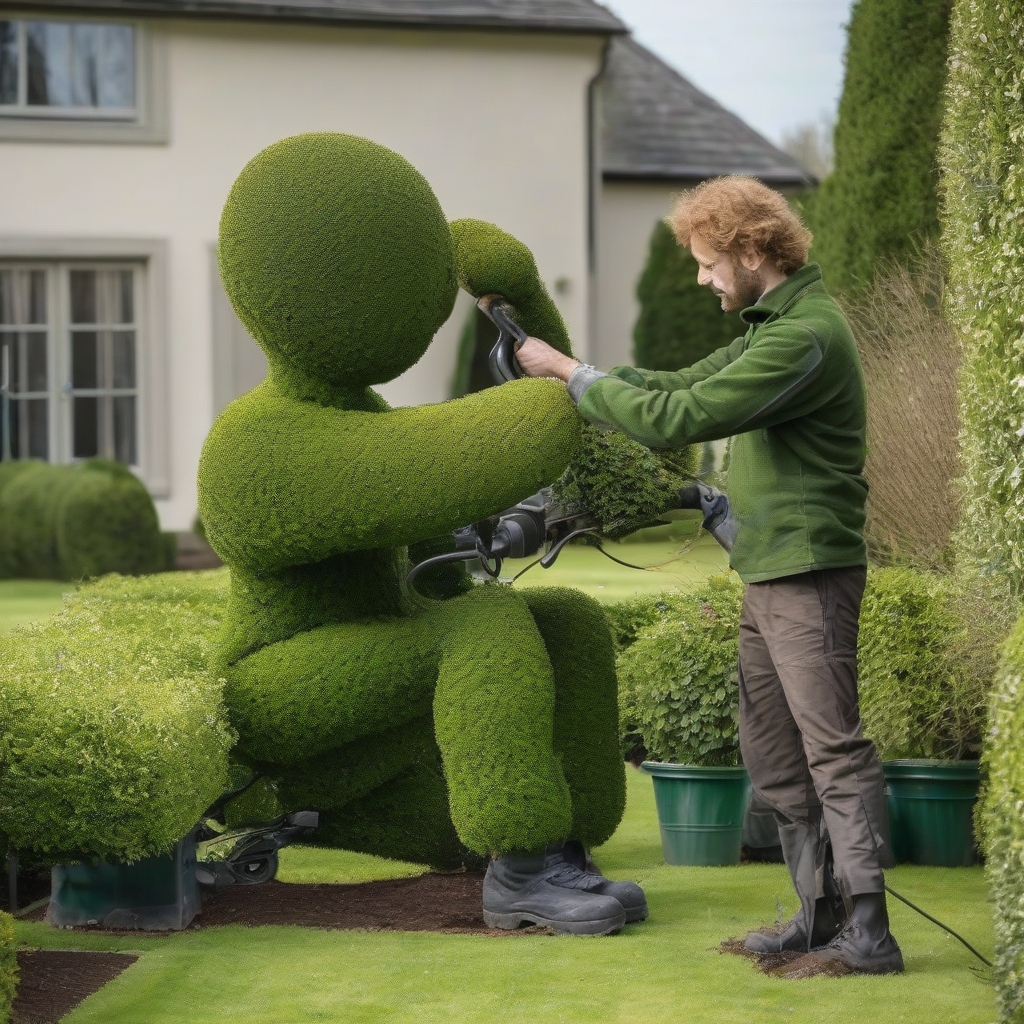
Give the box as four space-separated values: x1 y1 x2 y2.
218 133 458 387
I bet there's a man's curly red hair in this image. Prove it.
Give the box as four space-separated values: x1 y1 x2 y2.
668 174 812 274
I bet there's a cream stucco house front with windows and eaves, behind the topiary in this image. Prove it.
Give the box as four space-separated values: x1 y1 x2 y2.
0 0 806 529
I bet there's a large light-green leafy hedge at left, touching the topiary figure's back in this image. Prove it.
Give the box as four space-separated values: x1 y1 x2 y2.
0 570 232 862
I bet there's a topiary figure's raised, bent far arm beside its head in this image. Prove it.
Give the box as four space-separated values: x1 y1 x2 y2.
452 218 572 355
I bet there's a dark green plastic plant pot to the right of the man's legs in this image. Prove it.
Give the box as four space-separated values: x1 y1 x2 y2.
883 759 979 867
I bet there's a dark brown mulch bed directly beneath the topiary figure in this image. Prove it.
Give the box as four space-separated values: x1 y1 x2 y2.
27 872 549 936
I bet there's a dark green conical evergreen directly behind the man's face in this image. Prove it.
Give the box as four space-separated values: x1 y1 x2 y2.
633 220 745 370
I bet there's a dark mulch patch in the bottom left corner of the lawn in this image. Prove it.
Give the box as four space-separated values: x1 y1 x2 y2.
13 949 138 1024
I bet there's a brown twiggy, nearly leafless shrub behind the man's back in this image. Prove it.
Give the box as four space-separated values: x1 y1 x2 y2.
844 246 959 568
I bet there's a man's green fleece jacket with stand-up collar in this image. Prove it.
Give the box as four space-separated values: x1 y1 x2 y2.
570 263 867 583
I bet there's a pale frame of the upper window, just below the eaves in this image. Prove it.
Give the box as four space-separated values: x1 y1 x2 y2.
0 9 169 144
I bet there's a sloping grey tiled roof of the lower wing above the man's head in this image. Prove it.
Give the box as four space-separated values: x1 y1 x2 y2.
602 37 812 184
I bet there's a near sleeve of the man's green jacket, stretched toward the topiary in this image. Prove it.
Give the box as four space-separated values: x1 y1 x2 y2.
580 325 824 449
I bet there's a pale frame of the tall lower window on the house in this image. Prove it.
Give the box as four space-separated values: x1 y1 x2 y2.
0 238 171 498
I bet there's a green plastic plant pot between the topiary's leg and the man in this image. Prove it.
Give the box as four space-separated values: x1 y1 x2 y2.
640 761 751 867
